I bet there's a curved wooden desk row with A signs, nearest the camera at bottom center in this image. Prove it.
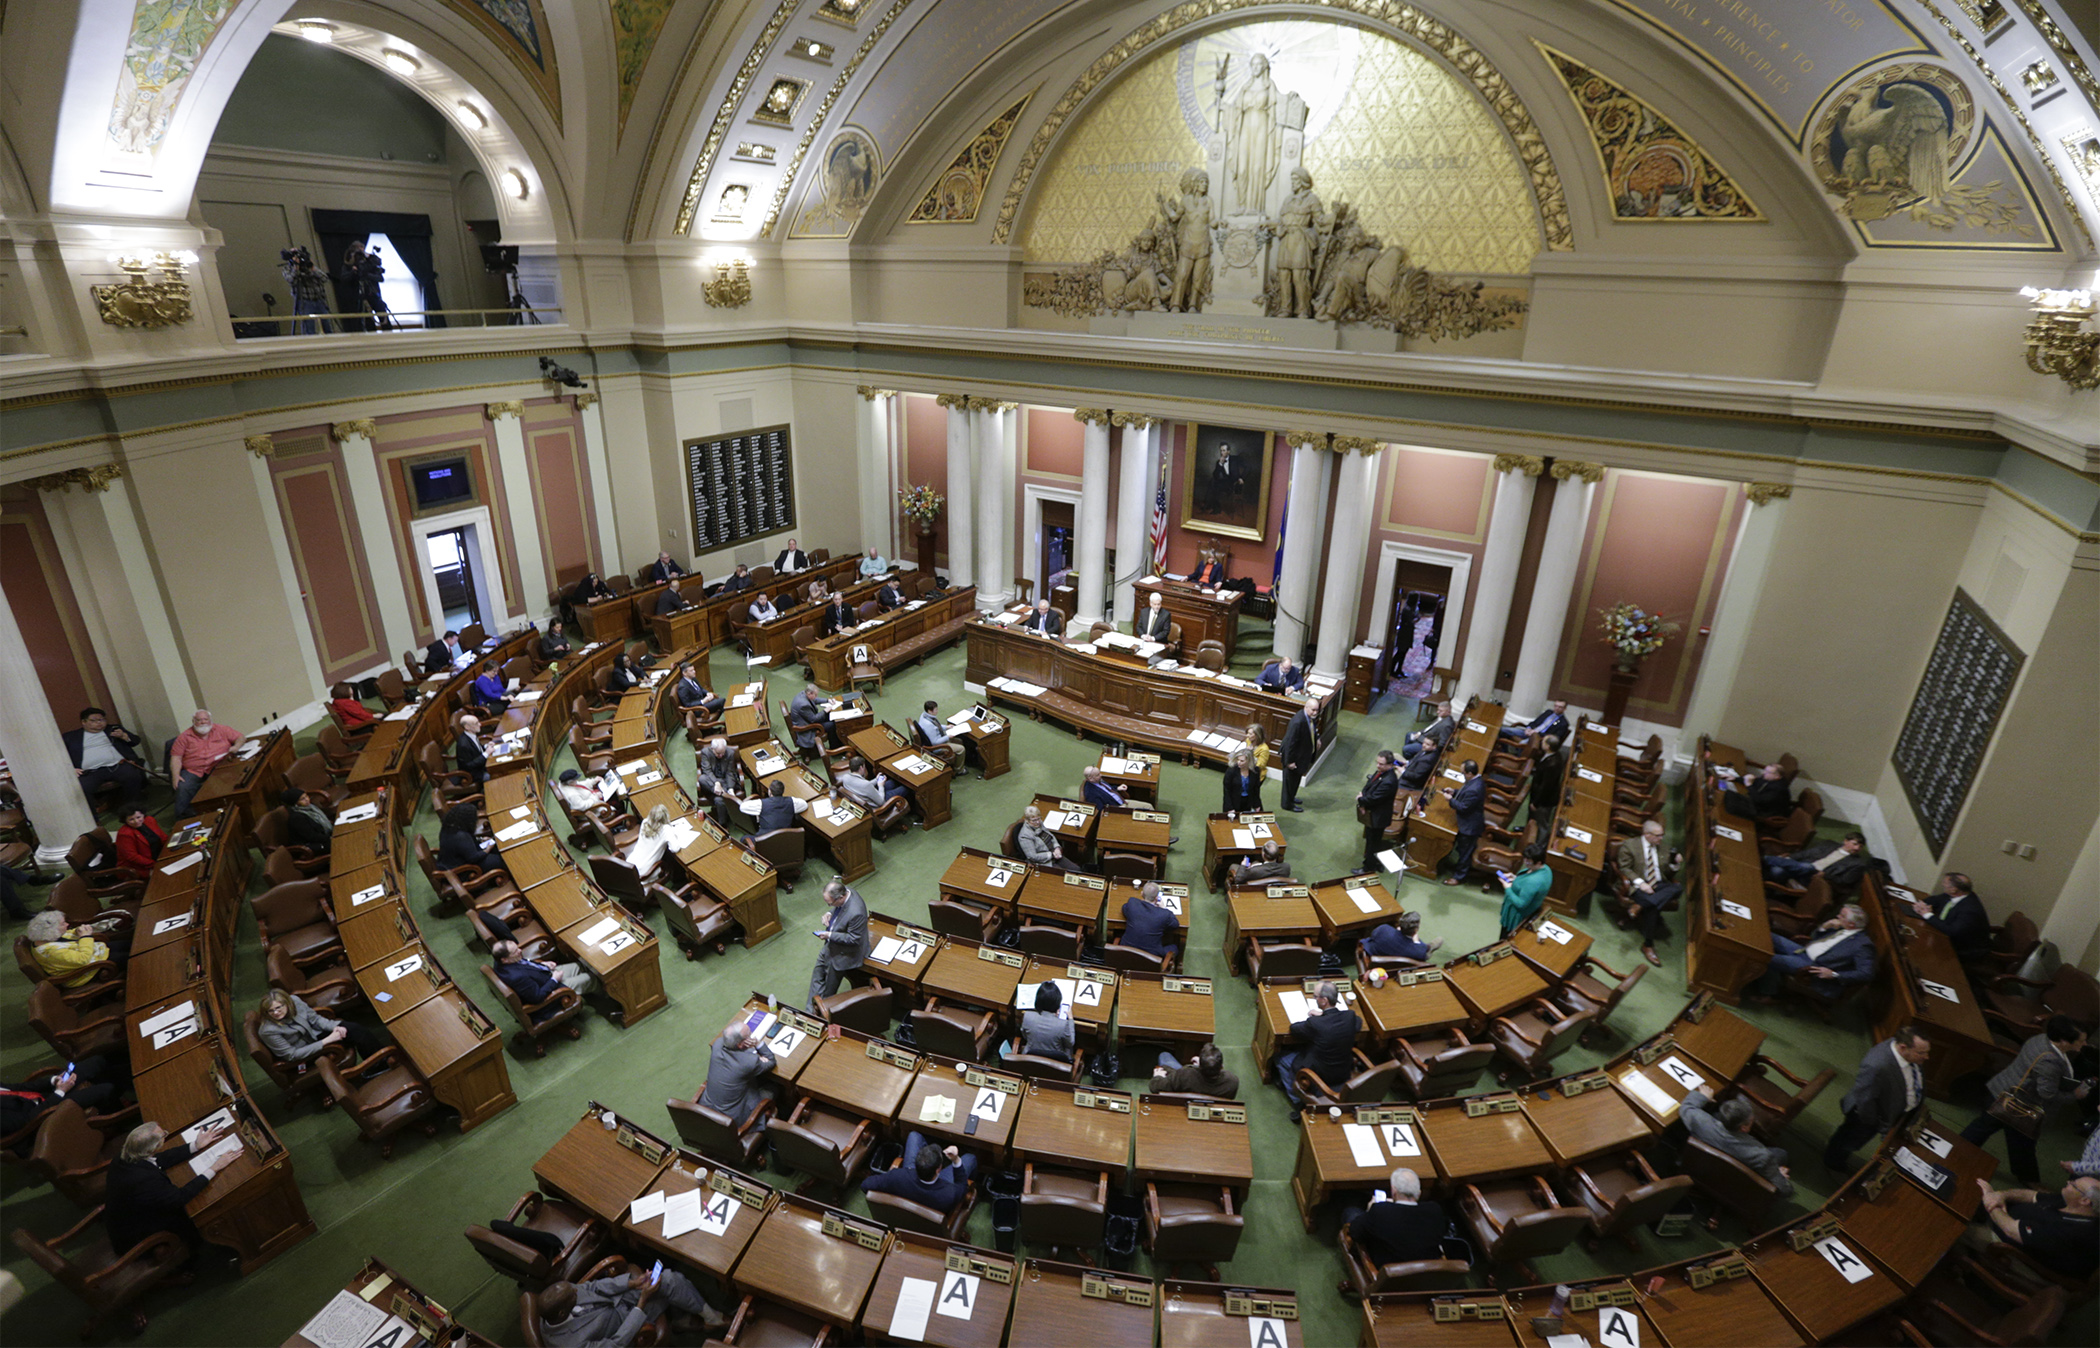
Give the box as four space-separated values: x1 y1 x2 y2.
533 1100 1304 1348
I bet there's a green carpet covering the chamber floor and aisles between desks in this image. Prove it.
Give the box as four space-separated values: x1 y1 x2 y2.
0 632 2096 1344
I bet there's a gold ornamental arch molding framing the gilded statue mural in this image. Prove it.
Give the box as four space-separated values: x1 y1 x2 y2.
991 0 1570 252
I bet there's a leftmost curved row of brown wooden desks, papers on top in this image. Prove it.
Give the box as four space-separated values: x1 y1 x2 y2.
124 797 315 1272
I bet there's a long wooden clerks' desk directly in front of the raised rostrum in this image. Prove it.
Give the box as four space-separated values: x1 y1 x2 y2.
964 622 1342 764
